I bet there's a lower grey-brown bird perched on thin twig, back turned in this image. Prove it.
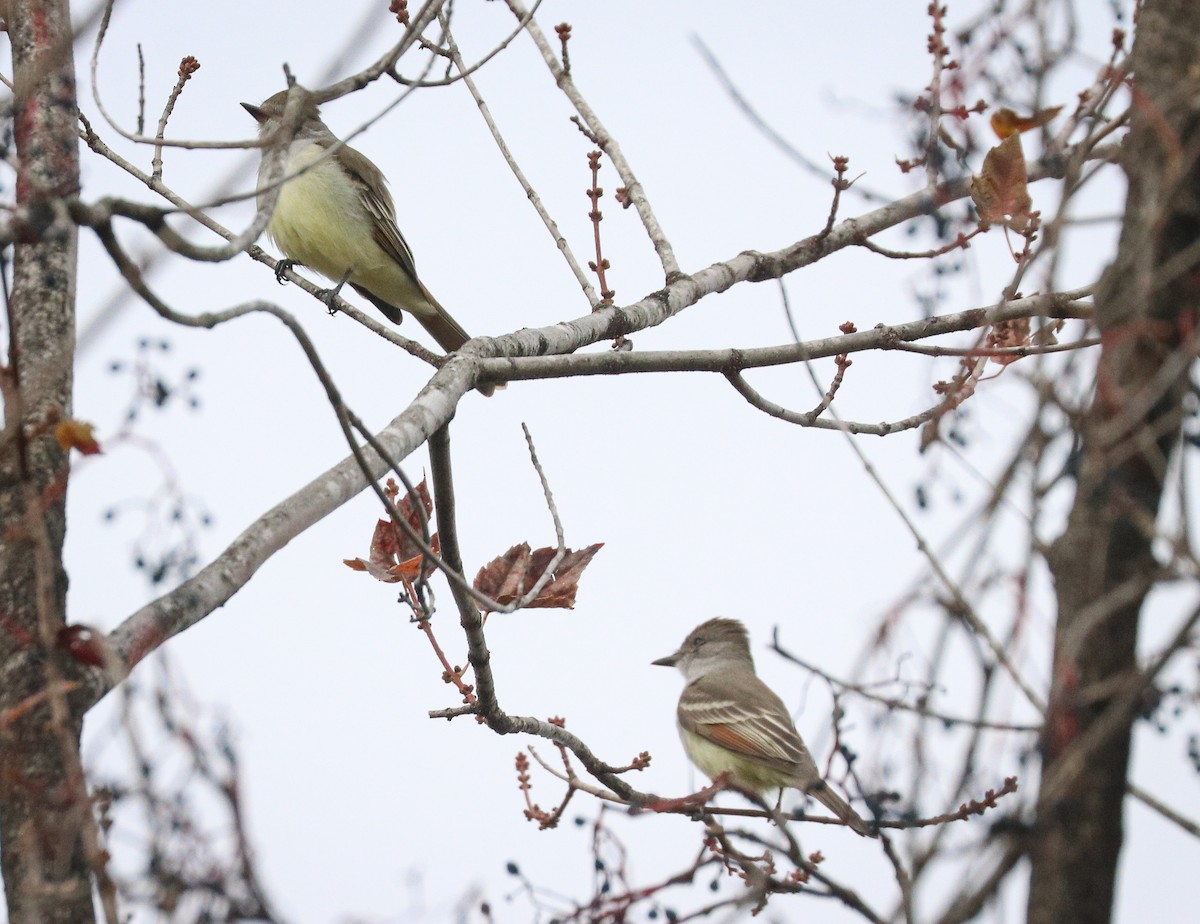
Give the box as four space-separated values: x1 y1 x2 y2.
653 619 878 838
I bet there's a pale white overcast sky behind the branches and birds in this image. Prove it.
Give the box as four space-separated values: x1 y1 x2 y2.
4 0 1200 924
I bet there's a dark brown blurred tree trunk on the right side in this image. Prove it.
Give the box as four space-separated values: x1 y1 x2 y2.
1027 0 1200 924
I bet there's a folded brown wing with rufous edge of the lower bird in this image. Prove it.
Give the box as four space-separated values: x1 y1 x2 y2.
678 673 816 774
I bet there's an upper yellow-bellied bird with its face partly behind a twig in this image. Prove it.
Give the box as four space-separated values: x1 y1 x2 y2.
242 90 470 353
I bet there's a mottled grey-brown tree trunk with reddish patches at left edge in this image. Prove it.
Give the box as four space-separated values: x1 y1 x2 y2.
0 0 95 924
